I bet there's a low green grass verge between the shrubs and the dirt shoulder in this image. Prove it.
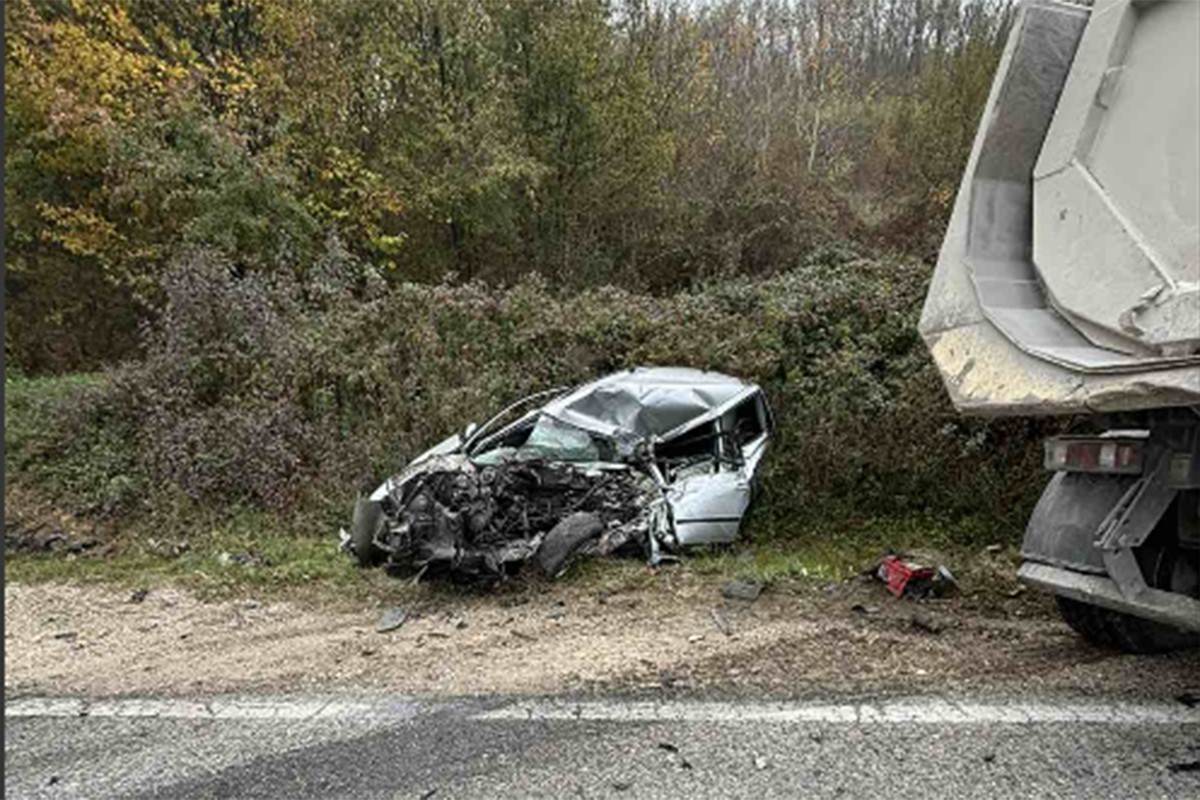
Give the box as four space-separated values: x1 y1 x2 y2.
5 503 1003 599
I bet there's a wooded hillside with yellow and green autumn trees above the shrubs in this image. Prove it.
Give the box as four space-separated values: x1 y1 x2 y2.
5 0 1012 373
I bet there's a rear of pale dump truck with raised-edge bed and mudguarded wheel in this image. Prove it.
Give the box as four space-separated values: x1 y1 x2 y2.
920 0 1200 652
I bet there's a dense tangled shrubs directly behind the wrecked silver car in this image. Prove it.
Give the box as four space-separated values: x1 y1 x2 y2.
14 241 1042 542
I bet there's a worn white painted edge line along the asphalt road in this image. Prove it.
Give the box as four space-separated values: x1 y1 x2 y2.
5 697 1200 726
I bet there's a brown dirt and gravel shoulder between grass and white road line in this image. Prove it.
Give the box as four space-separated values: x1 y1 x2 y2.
5 570 1200 697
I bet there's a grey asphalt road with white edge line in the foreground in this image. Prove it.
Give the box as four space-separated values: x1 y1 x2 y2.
5 696 1200 799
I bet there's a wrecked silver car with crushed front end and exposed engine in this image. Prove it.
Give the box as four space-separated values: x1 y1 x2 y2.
342 367 772 579
